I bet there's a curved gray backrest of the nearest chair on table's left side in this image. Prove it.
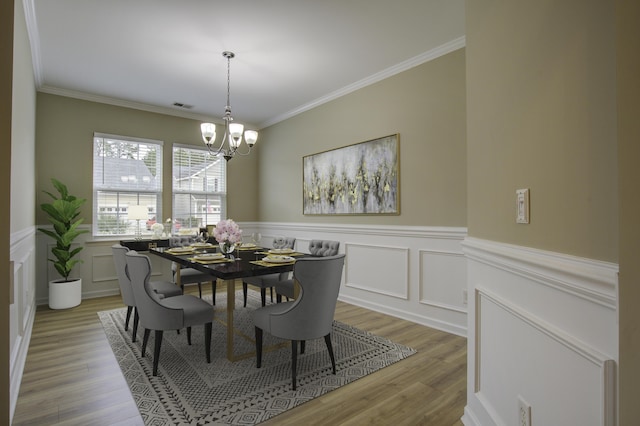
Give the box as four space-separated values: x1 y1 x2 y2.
125 250 184 330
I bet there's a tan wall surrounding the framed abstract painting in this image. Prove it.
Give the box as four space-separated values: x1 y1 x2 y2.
259 49 466 226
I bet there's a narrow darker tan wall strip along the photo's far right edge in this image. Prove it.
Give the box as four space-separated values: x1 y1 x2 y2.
616 0 640 425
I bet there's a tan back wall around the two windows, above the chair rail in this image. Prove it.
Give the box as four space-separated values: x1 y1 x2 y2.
36 93 259 224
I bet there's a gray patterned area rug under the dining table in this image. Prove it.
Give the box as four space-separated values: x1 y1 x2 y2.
98 291 415 426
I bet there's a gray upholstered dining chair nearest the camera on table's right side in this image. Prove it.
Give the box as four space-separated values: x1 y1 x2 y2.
253 254 345 390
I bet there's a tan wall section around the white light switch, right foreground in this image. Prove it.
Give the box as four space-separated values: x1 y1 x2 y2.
466 0 618 262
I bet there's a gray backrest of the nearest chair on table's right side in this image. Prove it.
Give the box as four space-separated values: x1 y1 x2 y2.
271 254 345 340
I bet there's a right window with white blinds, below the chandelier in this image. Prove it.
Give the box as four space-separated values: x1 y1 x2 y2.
172 145 227 233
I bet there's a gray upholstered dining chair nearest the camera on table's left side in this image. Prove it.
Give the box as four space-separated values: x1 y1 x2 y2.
126 251 214 376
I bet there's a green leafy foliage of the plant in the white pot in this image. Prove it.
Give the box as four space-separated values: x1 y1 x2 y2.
38 178 89 281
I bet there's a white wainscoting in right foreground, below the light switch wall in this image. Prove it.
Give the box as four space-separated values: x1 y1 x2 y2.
463 238 618 426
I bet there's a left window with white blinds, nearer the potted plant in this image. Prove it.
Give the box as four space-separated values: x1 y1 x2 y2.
93 133 162 236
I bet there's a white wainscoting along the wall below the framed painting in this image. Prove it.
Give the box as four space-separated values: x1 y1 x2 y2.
252 222 467 336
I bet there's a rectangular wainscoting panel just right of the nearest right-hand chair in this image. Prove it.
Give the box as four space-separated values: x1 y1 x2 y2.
344 243 409 300
